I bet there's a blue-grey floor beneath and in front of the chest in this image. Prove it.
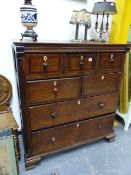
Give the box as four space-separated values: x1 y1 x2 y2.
19 120 131 175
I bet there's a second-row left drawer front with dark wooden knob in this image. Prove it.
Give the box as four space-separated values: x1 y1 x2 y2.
27 78 81 105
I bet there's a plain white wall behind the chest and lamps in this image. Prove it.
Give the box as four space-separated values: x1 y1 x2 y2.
0 0 112 129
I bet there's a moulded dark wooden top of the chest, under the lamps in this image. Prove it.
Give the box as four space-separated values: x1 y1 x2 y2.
13 41 128 53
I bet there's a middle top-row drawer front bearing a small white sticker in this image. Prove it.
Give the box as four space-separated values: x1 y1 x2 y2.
65 53 96 74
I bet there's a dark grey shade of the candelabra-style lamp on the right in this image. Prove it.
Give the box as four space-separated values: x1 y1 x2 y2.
92 1 117 15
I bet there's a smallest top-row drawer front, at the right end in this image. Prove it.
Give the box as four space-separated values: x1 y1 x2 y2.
99 53 124 72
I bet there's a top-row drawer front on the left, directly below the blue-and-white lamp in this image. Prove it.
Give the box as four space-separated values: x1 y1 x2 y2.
26 54 63 77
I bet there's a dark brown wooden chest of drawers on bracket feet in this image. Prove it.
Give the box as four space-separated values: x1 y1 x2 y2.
12 42 127 168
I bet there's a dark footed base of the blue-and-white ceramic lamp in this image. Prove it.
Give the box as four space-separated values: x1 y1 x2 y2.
21 29 38 41
